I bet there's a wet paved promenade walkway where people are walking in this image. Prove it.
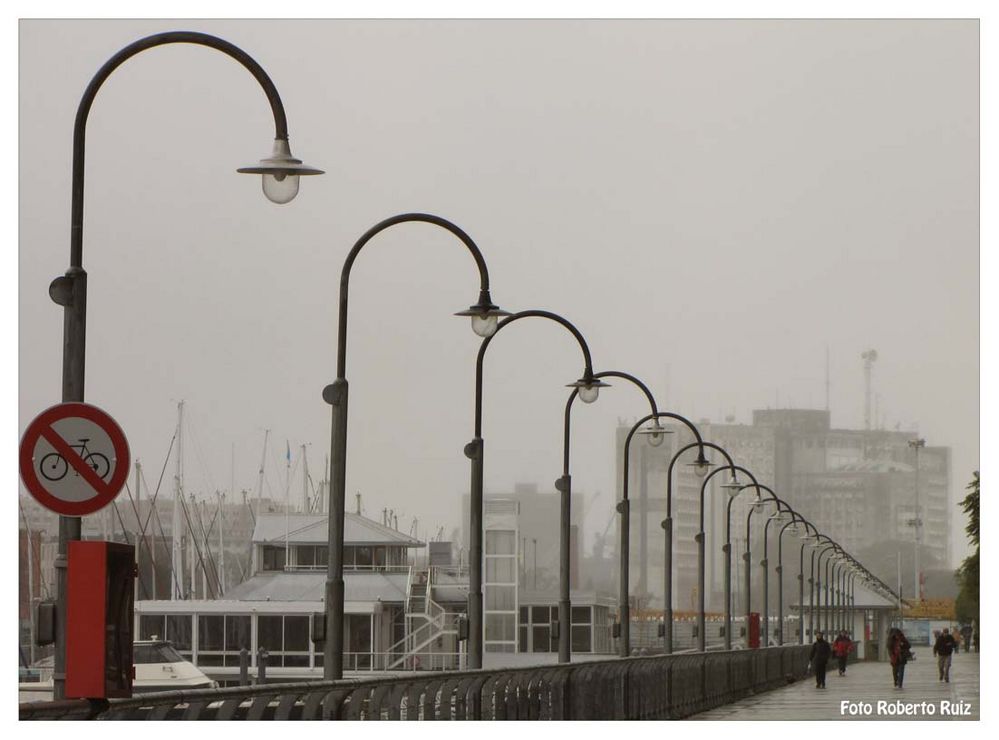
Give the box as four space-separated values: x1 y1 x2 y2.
690 647 980 720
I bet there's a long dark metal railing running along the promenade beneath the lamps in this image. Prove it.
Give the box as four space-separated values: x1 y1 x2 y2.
19 645 811 720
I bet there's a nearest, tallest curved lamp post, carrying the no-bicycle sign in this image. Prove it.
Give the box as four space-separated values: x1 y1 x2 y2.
49 31 322 699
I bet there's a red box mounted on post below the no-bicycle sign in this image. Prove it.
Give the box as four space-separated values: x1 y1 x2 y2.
66 541 135 699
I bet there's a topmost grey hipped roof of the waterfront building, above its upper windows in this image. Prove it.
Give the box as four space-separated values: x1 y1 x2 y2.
253 512 425 547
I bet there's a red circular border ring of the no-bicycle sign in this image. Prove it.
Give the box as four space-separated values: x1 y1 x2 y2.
20 401 131 516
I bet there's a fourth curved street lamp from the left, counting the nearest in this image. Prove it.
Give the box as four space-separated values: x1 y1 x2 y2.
555 370 667 663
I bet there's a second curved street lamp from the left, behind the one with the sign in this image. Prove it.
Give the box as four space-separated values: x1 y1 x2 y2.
323 213 507 680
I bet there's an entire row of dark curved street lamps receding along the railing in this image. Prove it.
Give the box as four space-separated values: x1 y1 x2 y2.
49 31 904 698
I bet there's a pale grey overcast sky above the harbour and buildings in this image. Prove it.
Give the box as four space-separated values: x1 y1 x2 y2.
18 20 979 556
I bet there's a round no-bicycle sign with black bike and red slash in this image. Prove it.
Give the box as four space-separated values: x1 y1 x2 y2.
20 403 130 516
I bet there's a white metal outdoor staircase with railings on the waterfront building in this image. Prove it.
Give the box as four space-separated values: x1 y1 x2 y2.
386 569 459 671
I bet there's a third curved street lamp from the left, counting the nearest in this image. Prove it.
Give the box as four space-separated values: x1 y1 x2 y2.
465 310 607 669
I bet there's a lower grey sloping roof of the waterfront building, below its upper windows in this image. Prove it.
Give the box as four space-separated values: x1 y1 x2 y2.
224 571 409 602
